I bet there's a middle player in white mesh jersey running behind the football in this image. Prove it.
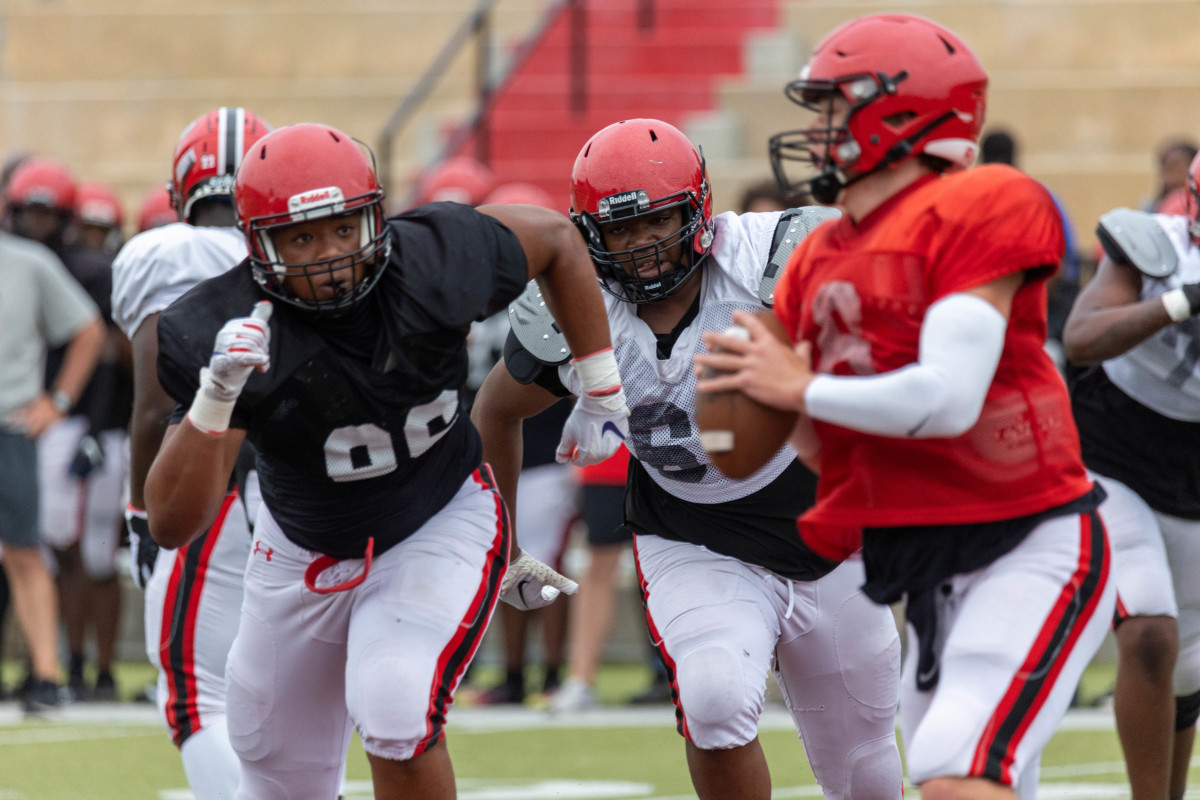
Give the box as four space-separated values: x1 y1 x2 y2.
473 119 901 800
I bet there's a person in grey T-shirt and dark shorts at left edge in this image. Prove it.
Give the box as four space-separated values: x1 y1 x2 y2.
0 155 106 714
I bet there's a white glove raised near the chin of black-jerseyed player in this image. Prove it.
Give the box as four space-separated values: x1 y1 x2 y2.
187 300 271 433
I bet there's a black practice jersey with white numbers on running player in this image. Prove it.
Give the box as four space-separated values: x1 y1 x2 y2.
158 203 528 558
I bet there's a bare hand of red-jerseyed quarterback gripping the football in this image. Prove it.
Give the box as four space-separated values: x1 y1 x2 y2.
692 311 816 411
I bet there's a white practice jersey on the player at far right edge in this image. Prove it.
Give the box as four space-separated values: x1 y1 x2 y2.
1104 213 1200 422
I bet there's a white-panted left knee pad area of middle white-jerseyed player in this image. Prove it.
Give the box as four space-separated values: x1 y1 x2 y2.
676 643 762 750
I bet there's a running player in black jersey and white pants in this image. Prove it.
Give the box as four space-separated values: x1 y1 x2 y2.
146 124 628 800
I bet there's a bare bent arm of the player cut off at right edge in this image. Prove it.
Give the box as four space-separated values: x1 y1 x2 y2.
1062 255 1175 365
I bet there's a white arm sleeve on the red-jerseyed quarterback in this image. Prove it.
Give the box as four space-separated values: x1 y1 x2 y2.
804 294 1008 439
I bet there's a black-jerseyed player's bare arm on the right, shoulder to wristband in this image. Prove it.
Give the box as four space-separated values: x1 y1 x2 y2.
479 205 612 357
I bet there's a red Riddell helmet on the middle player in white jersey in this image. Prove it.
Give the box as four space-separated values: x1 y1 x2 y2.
570 119 713 303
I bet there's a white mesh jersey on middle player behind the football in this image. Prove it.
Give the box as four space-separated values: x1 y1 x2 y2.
559 211 796 504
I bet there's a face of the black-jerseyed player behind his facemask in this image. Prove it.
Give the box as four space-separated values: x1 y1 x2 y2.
275 211 366 300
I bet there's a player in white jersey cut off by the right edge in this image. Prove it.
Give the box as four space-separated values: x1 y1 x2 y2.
1063 157 1200 798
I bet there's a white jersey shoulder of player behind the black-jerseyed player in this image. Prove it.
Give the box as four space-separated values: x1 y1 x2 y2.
113 222 246 338
